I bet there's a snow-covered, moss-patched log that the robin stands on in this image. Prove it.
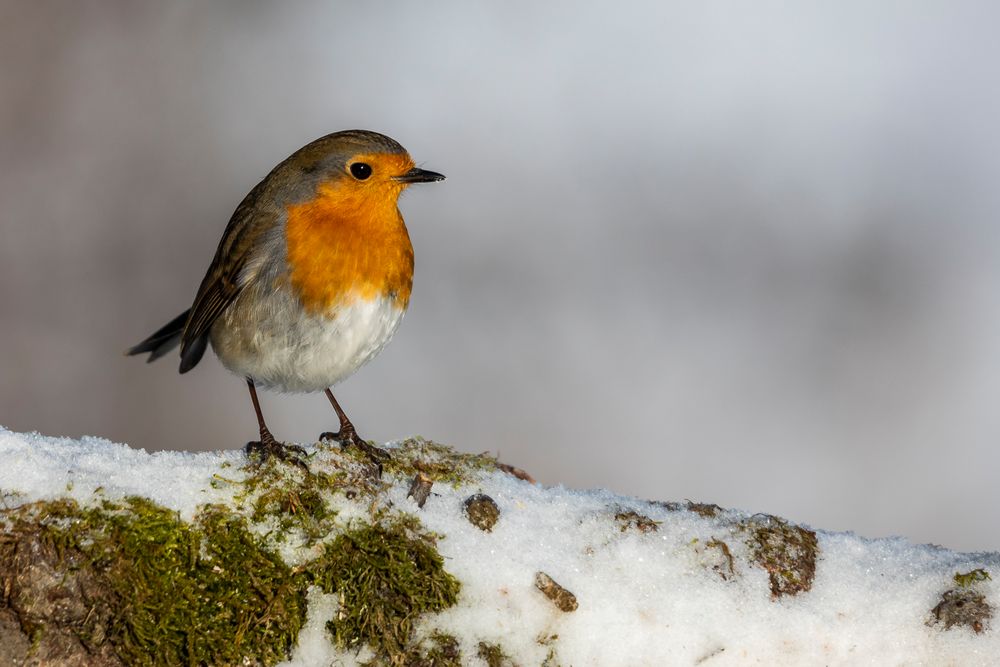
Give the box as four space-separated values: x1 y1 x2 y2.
0 429 1000 667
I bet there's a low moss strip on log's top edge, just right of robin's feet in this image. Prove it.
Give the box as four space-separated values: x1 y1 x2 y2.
384 438 497 487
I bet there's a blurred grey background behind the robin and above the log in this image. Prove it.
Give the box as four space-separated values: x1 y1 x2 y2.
0 0 1000 550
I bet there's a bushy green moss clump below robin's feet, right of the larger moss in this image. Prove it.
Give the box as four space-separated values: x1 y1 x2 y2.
309 517 460 665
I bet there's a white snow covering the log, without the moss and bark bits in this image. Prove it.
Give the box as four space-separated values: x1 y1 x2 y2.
0 429 1000 667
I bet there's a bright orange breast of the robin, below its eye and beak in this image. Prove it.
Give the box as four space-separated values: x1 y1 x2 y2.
285 177 413 312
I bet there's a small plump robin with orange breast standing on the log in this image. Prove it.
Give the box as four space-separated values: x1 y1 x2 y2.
127 130 444 464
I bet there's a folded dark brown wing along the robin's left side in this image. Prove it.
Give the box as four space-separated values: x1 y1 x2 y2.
180 188 274 373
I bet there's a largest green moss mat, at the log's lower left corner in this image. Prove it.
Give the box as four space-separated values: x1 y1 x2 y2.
0 498 305 665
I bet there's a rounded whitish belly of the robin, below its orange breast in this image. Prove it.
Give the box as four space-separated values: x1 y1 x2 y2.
211 297 405 392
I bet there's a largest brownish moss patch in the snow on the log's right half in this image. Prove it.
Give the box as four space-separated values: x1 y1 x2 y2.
741 515 819 598
